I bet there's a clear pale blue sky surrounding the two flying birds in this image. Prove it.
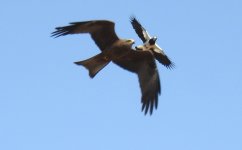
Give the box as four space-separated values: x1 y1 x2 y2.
0 0 242 150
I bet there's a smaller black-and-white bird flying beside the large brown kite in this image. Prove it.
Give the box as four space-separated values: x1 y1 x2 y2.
130 16 174 69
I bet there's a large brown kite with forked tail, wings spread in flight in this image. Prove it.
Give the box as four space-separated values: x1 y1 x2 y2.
52 20 161 115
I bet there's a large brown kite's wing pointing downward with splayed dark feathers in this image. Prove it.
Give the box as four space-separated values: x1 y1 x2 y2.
114 50 161 114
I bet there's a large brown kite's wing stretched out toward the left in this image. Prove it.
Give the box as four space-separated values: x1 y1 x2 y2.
52 20 119 51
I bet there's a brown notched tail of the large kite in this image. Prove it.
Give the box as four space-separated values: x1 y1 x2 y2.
74 53 111 78
